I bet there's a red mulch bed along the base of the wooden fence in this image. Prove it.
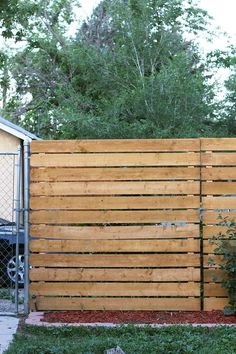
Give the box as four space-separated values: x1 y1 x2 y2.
42 311 236 324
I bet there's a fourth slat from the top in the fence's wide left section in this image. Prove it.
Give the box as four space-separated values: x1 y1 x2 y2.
30 181 200 196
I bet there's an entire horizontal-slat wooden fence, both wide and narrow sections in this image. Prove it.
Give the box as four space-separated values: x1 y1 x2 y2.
30 139 236 310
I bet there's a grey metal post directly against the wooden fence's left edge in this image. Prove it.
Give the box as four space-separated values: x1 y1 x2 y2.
24 140 29 314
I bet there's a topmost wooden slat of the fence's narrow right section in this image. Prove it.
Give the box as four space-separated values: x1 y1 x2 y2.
201 138 236 151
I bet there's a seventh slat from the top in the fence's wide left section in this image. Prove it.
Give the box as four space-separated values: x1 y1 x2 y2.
30 224 199 240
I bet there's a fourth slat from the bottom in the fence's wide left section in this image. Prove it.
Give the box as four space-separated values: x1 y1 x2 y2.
30 254 200 268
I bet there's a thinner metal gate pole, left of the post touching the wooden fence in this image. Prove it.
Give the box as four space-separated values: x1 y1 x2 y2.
15 146 21 313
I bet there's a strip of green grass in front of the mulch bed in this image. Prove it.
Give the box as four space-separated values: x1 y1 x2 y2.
7 326 236 354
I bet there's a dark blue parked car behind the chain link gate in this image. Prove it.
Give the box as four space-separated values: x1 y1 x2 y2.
0 218 24 286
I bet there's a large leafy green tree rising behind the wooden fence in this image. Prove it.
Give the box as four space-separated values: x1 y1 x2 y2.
0 0 222 138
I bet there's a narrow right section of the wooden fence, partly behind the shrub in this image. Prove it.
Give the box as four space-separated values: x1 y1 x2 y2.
201 138 236 310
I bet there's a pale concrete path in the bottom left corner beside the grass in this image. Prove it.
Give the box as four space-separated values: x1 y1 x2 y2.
0 315 19 354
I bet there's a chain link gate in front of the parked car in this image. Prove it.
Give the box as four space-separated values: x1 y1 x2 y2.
0 147 24 313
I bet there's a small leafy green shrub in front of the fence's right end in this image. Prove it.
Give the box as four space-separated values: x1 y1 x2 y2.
210 217 236 315
